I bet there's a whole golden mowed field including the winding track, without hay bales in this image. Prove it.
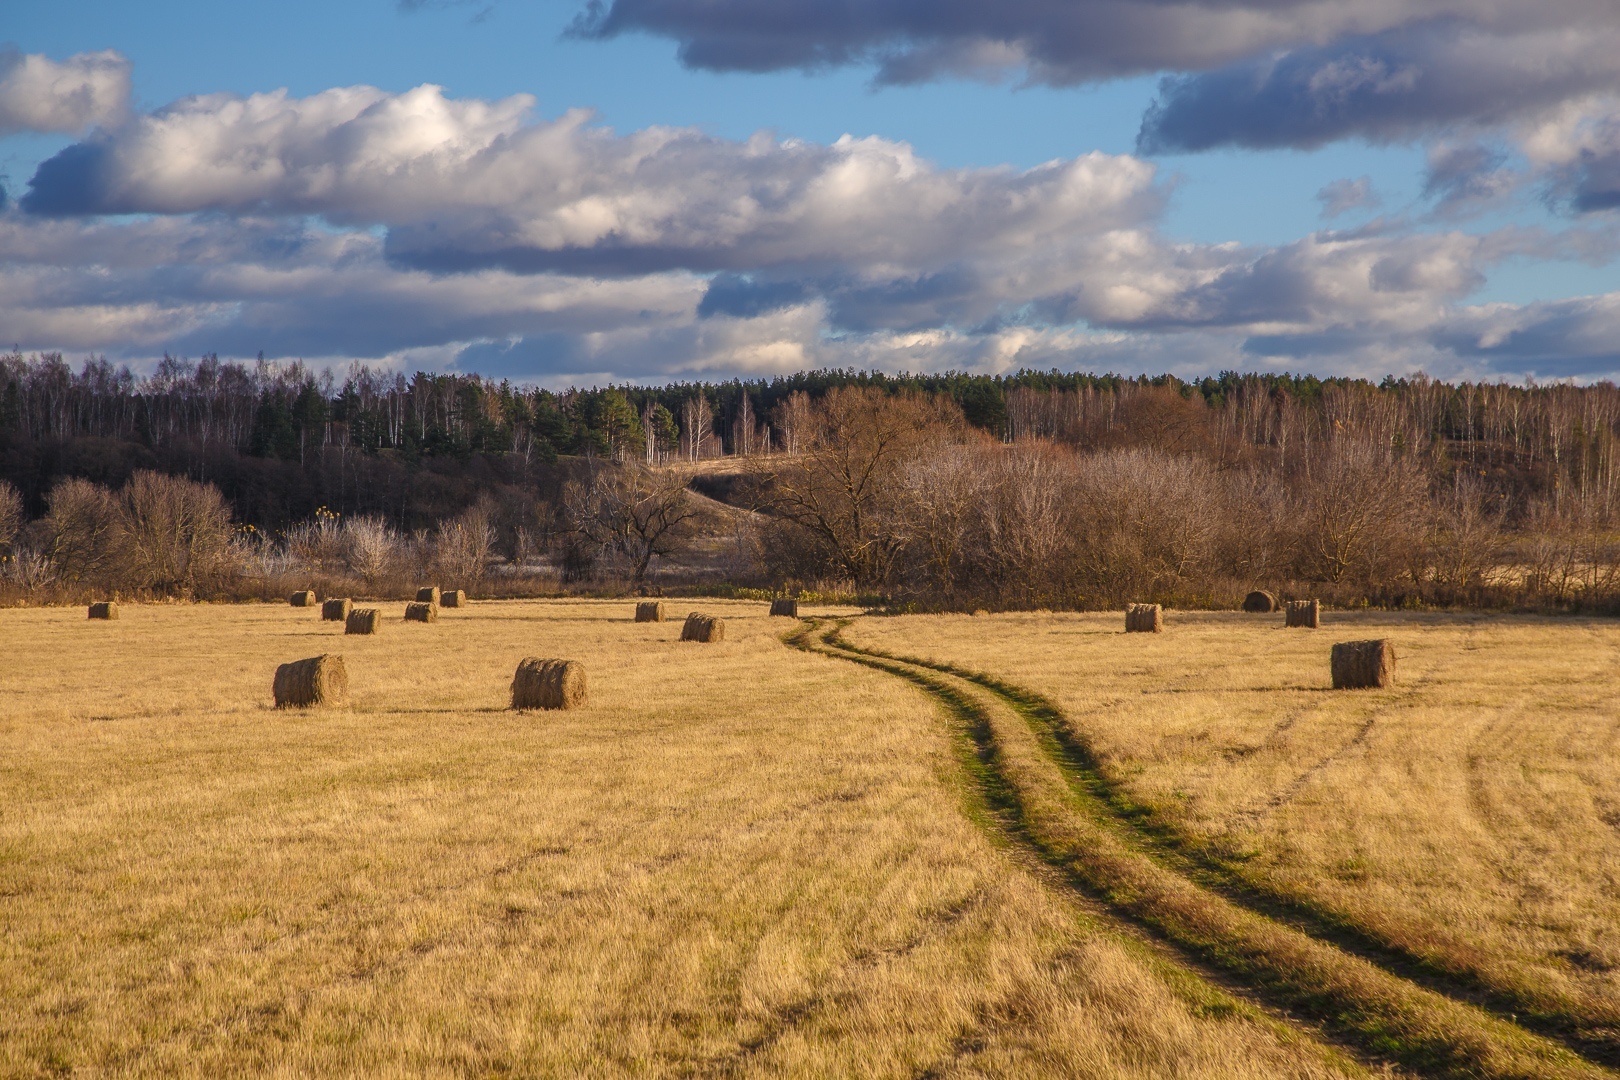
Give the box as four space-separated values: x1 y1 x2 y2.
0 601 1620 1077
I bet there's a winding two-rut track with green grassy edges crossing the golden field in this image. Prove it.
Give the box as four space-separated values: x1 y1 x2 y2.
789 620 1615 1078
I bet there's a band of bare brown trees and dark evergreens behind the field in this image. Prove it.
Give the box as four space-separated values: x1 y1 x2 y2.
0 353 1620 609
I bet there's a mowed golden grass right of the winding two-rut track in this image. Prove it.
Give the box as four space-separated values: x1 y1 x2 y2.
846 612 1620 1057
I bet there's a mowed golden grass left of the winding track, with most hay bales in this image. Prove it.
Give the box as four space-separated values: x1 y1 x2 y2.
0 601 1361 1078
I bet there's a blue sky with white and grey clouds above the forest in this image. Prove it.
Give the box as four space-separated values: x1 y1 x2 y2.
9 0 1620 387
